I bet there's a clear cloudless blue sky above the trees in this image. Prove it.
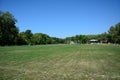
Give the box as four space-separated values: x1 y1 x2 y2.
0 0 120 38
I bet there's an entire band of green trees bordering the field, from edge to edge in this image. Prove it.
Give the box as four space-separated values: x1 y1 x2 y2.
0 11 120 46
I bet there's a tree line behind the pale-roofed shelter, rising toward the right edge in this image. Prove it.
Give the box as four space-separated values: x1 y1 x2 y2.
63 23 120 44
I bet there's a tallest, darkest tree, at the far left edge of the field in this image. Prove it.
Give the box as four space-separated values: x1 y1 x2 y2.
0 11 19 46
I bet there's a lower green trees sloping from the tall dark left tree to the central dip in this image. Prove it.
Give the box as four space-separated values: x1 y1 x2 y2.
17 30 64 45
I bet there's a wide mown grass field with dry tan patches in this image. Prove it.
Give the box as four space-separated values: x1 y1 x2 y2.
0 45 120 80
